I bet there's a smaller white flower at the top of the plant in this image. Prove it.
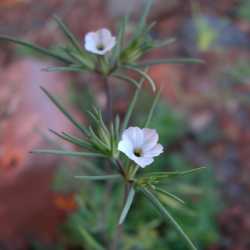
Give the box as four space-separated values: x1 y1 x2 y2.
85 29 116 55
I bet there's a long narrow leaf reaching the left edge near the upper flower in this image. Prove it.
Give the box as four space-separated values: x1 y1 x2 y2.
0 36 73 64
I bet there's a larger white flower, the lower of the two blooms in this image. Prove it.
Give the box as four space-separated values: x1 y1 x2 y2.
118 127 163 168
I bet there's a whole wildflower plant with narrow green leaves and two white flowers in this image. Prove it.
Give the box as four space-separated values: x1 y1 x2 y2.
0 1 207 249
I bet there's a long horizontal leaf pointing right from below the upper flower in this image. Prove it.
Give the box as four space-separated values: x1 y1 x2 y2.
131 58 204 68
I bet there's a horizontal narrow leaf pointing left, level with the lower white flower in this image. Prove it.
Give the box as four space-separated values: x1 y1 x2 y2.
31 149 105 157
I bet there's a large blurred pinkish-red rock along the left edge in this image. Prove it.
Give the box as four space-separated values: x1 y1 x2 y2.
0 59 78 250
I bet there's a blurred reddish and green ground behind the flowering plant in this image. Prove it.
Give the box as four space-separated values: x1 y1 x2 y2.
0 0 250 250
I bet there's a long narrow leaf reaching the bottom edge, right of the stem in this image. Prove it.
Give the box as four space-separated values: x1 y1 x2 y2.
141 188 197 250
